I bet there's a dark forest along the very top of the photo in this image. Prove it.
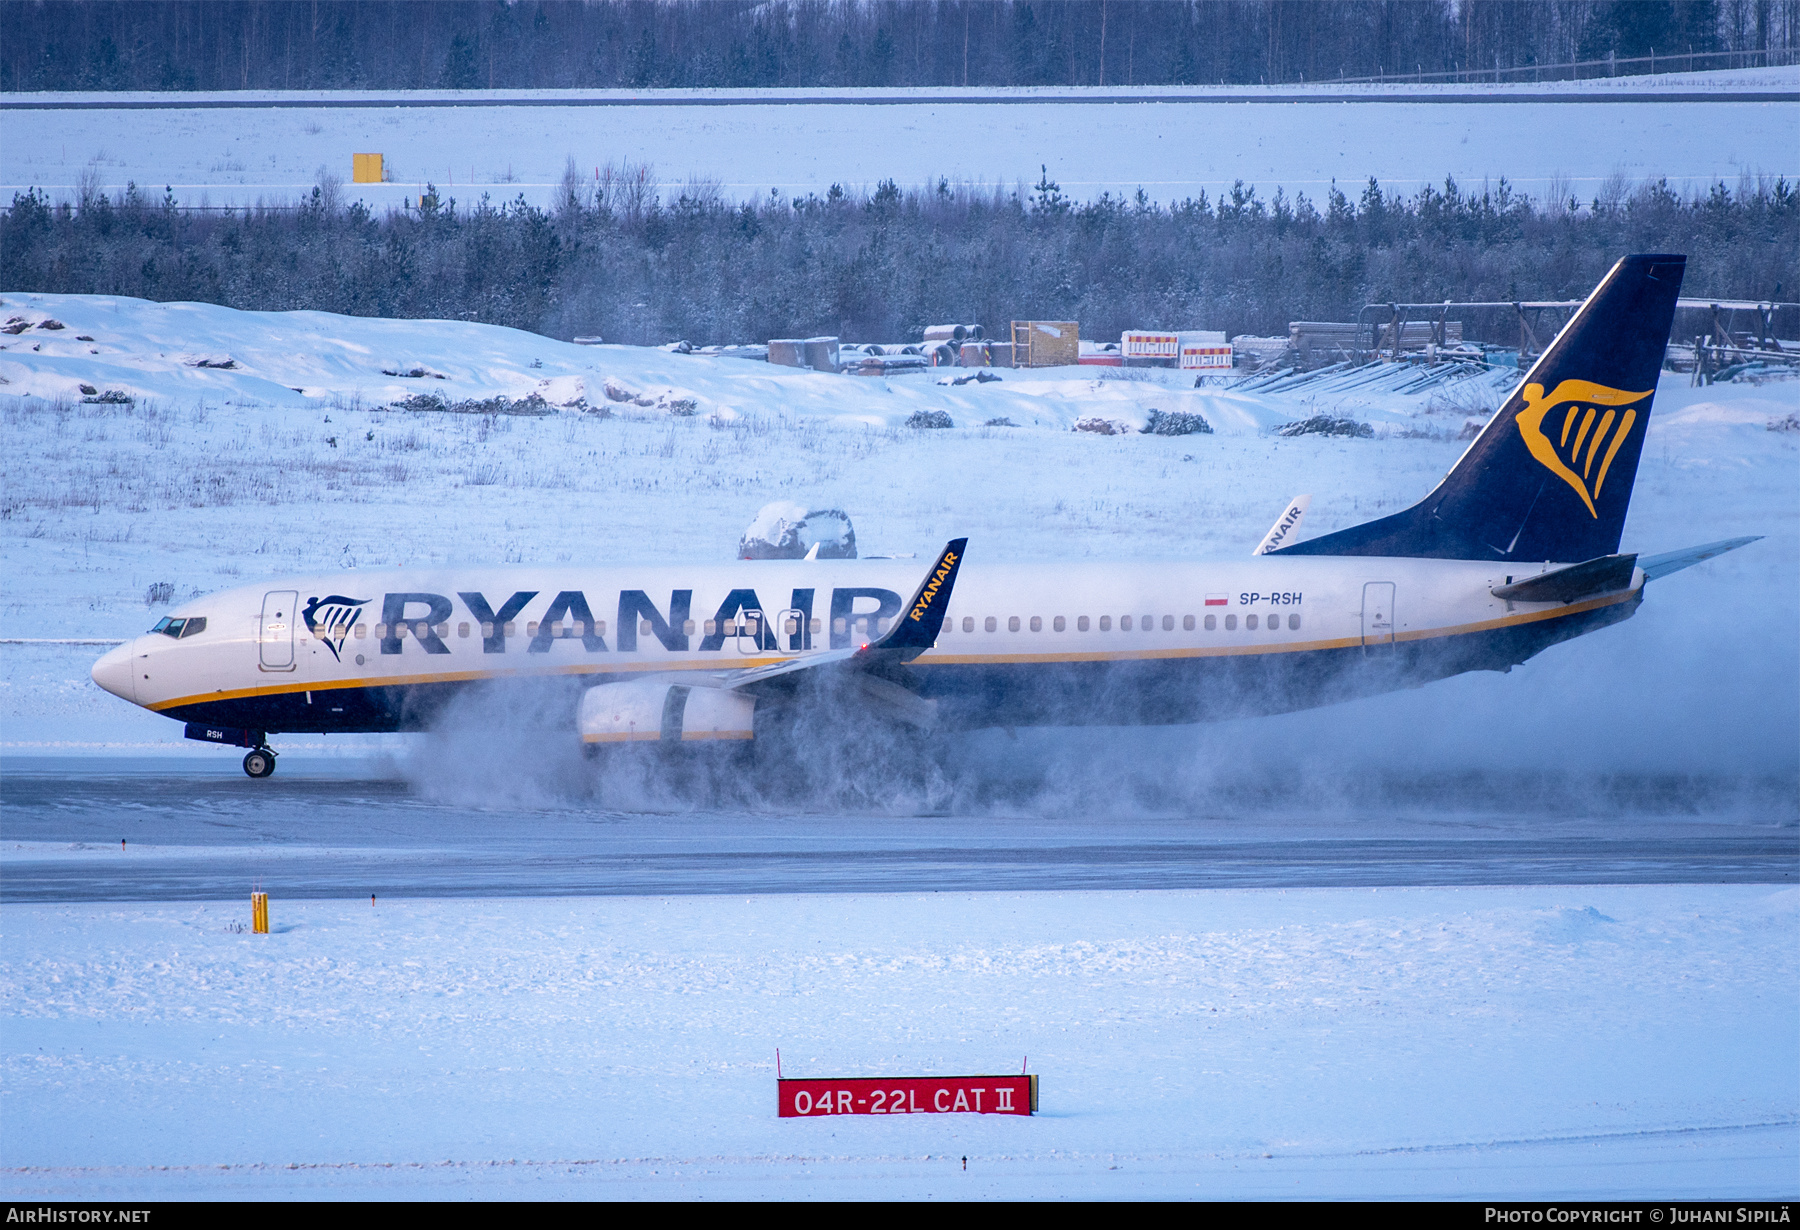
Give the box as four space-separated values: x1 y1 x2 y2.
0 0 1800 90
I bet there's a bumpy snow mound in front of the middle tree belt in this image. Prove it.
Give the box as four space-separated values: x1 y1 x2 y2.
0 294 1510 434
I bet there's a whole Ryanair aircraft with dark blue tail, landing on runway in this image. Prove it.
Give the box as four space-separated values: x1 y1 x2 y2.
94 256 1753 778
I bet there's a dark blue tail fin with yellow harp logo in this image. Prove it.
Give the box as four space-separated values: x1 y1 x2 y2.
1271 256 1687 560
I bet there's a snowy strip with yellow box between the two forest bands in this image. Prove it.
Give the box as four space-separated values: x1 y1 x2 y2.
0 68 1800 207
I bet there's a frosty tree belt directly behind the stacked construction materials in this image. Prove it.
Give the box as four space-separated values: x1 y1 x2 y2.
0 166 1800 344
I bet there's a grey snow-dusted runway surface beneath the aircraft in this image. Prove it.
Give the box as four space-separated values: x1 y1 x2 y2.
0 758 1800 902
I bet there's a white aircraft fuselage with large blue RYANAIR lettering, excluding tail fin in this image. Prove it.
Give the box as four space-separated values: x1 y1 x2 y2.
94 556 1643 729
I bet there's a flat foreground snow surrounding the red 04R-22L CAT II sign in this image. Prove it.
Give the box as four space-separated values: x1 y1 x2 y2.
0 889 1800 1199
